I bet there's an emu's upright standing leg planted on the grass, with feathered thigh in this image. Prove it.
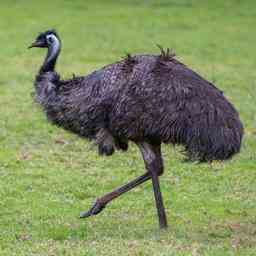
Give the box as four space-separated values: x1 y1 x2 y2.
138 142 167 228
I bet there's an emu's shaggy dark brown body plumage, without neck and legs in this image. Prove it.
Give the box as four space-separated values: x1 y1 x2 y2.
57 55 243 160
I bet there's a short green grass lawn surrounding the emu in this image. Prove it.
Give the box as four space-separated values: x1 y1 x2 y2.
0 0 256 256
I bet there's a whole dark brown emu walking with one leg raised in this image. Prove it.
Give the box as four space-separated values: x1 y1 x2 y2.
29 30 243 228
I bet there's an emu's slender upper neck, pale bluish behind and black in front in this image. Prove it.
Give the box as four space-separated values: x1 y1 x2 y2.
40 41 60 73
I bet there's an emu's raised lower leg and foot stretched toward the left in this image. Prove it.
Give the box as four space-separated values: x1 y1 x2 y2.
80 172 151 218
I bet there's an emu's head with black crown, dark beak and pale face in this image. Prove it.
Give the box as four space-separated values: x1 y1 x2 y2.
28 30 60 49
